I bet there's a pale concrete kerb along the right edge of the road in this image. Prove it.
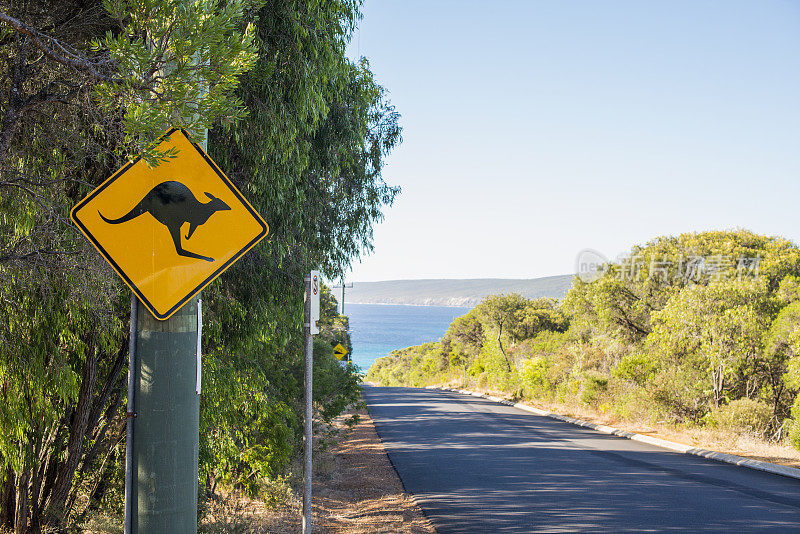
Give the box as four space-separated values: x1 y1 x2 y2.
426 386 800 480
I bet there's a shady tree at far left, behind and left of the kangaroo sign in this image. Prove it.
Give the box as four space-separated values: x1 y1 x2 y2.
0 0 257 533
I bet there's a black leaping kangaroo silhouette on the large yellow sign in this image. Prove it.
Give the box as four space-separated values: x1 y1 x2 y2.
97 181 231 261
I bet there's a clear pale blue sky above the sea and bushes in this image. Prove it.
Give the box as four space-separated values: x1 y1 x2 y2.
349 0 800 281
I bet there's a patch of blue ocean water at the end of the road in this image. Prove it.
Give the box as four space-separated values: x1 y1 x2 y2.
344 304 471 373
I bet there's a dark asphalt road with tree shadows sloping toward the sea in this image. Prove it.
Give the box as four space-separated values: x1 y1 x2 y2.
364 387 800 534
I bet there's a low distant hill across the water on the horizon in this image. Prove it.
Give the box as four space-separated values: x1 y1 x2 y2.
344 274 574 306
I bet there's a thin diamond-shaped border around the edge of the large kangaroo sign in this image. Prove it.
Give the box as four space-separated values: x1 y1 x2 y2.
69 128 269 321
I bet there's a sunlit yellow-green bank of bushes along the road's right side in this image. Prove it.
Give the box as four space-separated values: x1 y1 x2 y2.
371 230 800 456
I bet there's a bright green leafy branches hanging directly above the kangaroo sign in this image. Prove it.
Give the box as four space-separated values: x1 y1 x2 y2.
91 0 263 164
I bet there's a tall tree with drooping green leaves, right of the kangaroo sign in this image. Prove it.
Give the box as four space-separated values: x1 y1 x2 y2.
201 0 401 489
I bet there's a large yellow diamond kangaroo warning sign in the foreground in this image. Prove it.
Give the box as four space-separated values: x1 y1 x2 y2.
72 129 269 320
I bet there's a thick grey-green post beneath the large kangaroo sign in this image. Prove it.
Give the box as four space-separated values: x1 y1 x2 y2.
130 295 202 534
